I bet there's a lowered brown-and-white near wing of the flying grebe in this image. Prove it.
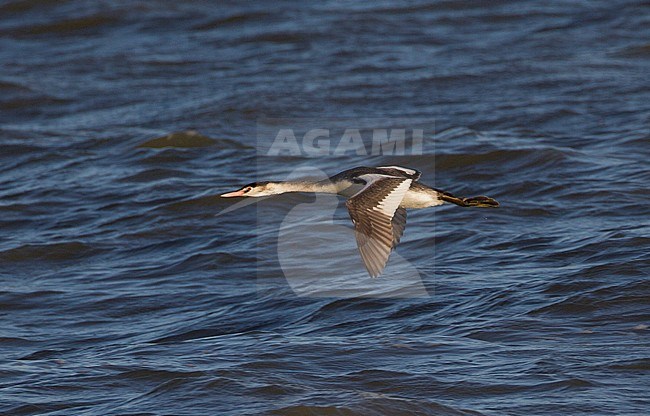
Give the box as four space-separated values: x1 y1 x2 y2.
346 174 413 277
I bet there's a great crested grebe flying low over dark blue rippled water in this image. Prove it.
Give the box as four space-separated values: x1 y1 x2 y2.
221 166 499 277
